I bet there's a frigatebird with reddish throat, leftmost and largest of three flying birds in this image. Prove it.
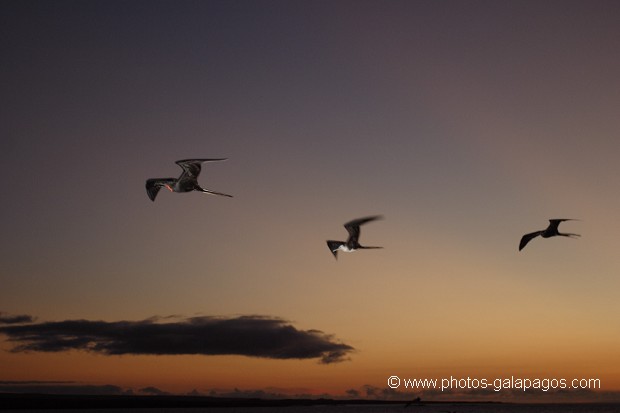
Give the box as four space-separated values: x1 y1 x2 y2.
146 158 232 202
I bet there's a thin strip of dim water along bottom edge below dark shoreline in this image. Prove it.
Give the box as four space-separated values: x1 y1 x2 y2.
0 403 620 413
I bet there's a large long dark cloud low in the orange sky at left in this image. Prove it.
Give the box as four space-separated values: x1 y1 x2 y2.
0 316 354 364
